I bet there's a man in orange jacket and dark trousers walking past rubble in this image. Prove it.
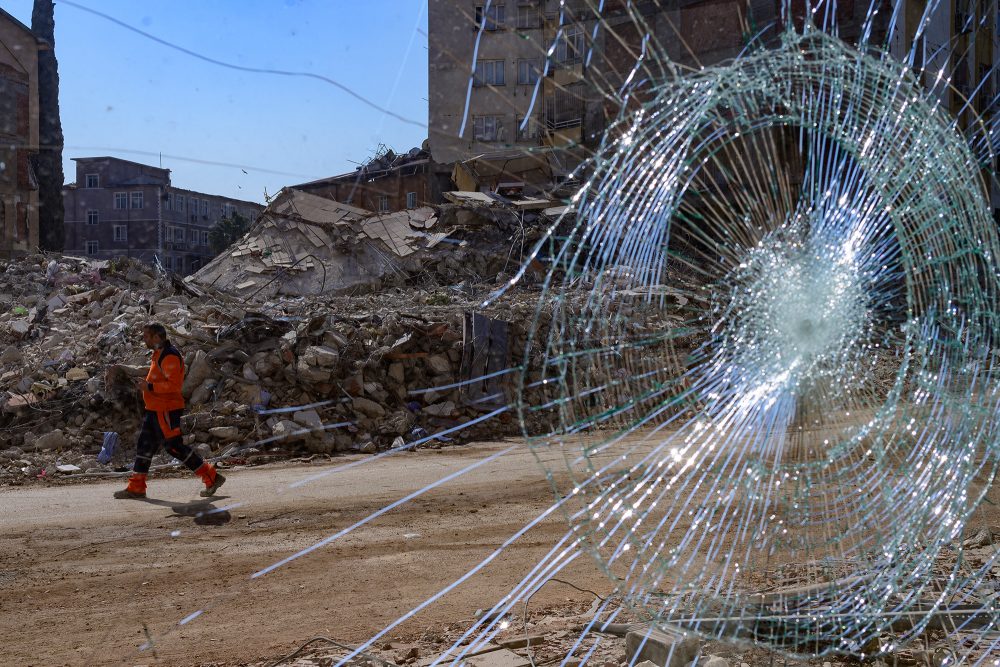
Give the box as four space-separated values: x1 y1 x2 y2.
115 322 226 499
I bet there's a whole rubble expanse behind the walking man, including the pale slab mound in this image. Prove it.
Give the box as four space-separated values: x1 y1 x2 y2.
0 190 728 480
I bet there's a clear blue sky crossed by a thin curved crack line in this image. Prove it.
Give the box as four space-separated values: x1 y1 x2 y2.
2 0 427 202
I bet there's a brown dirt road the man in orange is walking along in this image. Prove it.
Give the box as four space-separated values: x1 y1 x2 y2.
0 443 609 665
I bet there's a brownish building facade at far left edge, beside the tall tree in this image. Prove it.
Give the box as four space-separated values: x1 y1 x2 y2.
0 9 42 257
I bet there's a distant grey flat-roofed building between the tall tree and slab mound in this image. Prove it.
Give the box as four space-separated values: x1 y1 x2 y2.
63 157 264 274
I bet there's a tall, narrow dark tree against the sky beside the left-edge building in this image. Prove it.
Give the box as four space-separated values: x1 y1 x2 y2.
31 0 65 252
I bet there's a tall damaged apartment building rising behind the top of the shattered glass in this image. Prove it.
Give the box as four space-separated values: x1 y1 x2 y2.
428 0 988 207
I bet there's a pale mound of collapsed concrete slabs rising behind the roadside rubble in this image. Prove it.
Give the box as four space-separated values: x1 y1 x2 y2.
187 188 556 298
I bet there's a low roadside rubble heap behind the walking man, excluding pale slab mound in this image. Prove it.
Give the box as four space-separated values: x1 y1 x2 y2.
0 245 672 480
